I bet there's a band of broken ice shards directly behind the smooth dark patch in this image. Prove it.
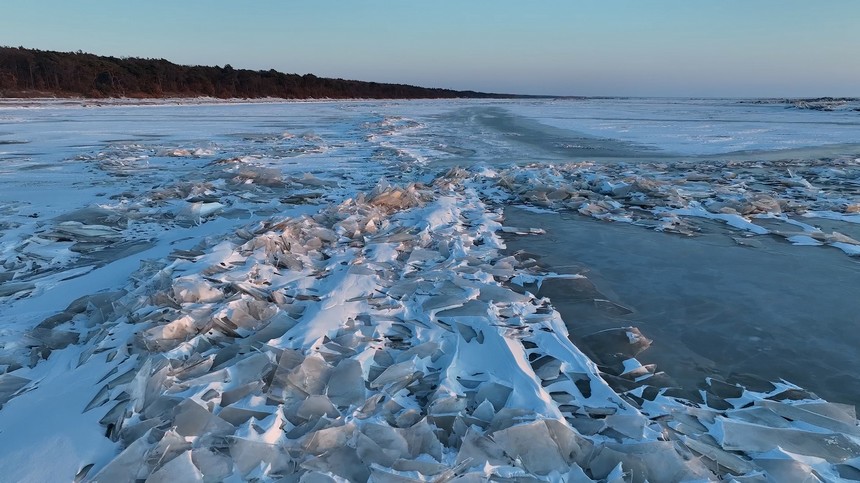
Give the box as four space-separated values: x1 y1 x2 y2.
490 158 860 255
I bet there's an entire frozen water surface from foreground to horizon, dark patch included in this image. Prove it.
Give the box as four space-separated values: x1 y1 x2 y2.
0 99 860 481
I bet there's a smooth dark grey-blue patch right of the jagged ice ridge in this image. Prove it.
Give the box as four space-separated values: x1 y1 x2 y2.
506 208 860 405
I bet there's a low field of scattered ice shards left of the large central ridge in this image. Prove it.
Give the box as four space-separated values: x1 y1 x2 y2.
0 137 350 298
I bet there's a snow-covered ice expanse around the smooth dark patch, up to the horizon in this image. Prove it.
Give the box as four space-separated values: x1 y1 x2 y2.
0 101 860 482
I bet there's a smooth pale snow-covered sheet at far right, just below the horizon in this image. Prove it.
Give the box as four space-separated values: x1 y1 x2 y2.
510 99 860 155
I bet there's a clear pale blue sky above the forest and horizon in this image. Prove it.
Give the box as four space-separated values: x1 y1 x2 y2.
0 0 860 97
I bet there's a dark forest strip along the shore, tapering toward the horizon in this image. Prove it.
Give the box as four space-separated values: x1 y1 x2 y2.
0 47 508 99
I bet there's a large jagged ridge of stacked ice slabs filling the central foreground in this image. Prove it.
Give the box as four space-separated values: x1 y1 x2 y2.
0 169 860 482
